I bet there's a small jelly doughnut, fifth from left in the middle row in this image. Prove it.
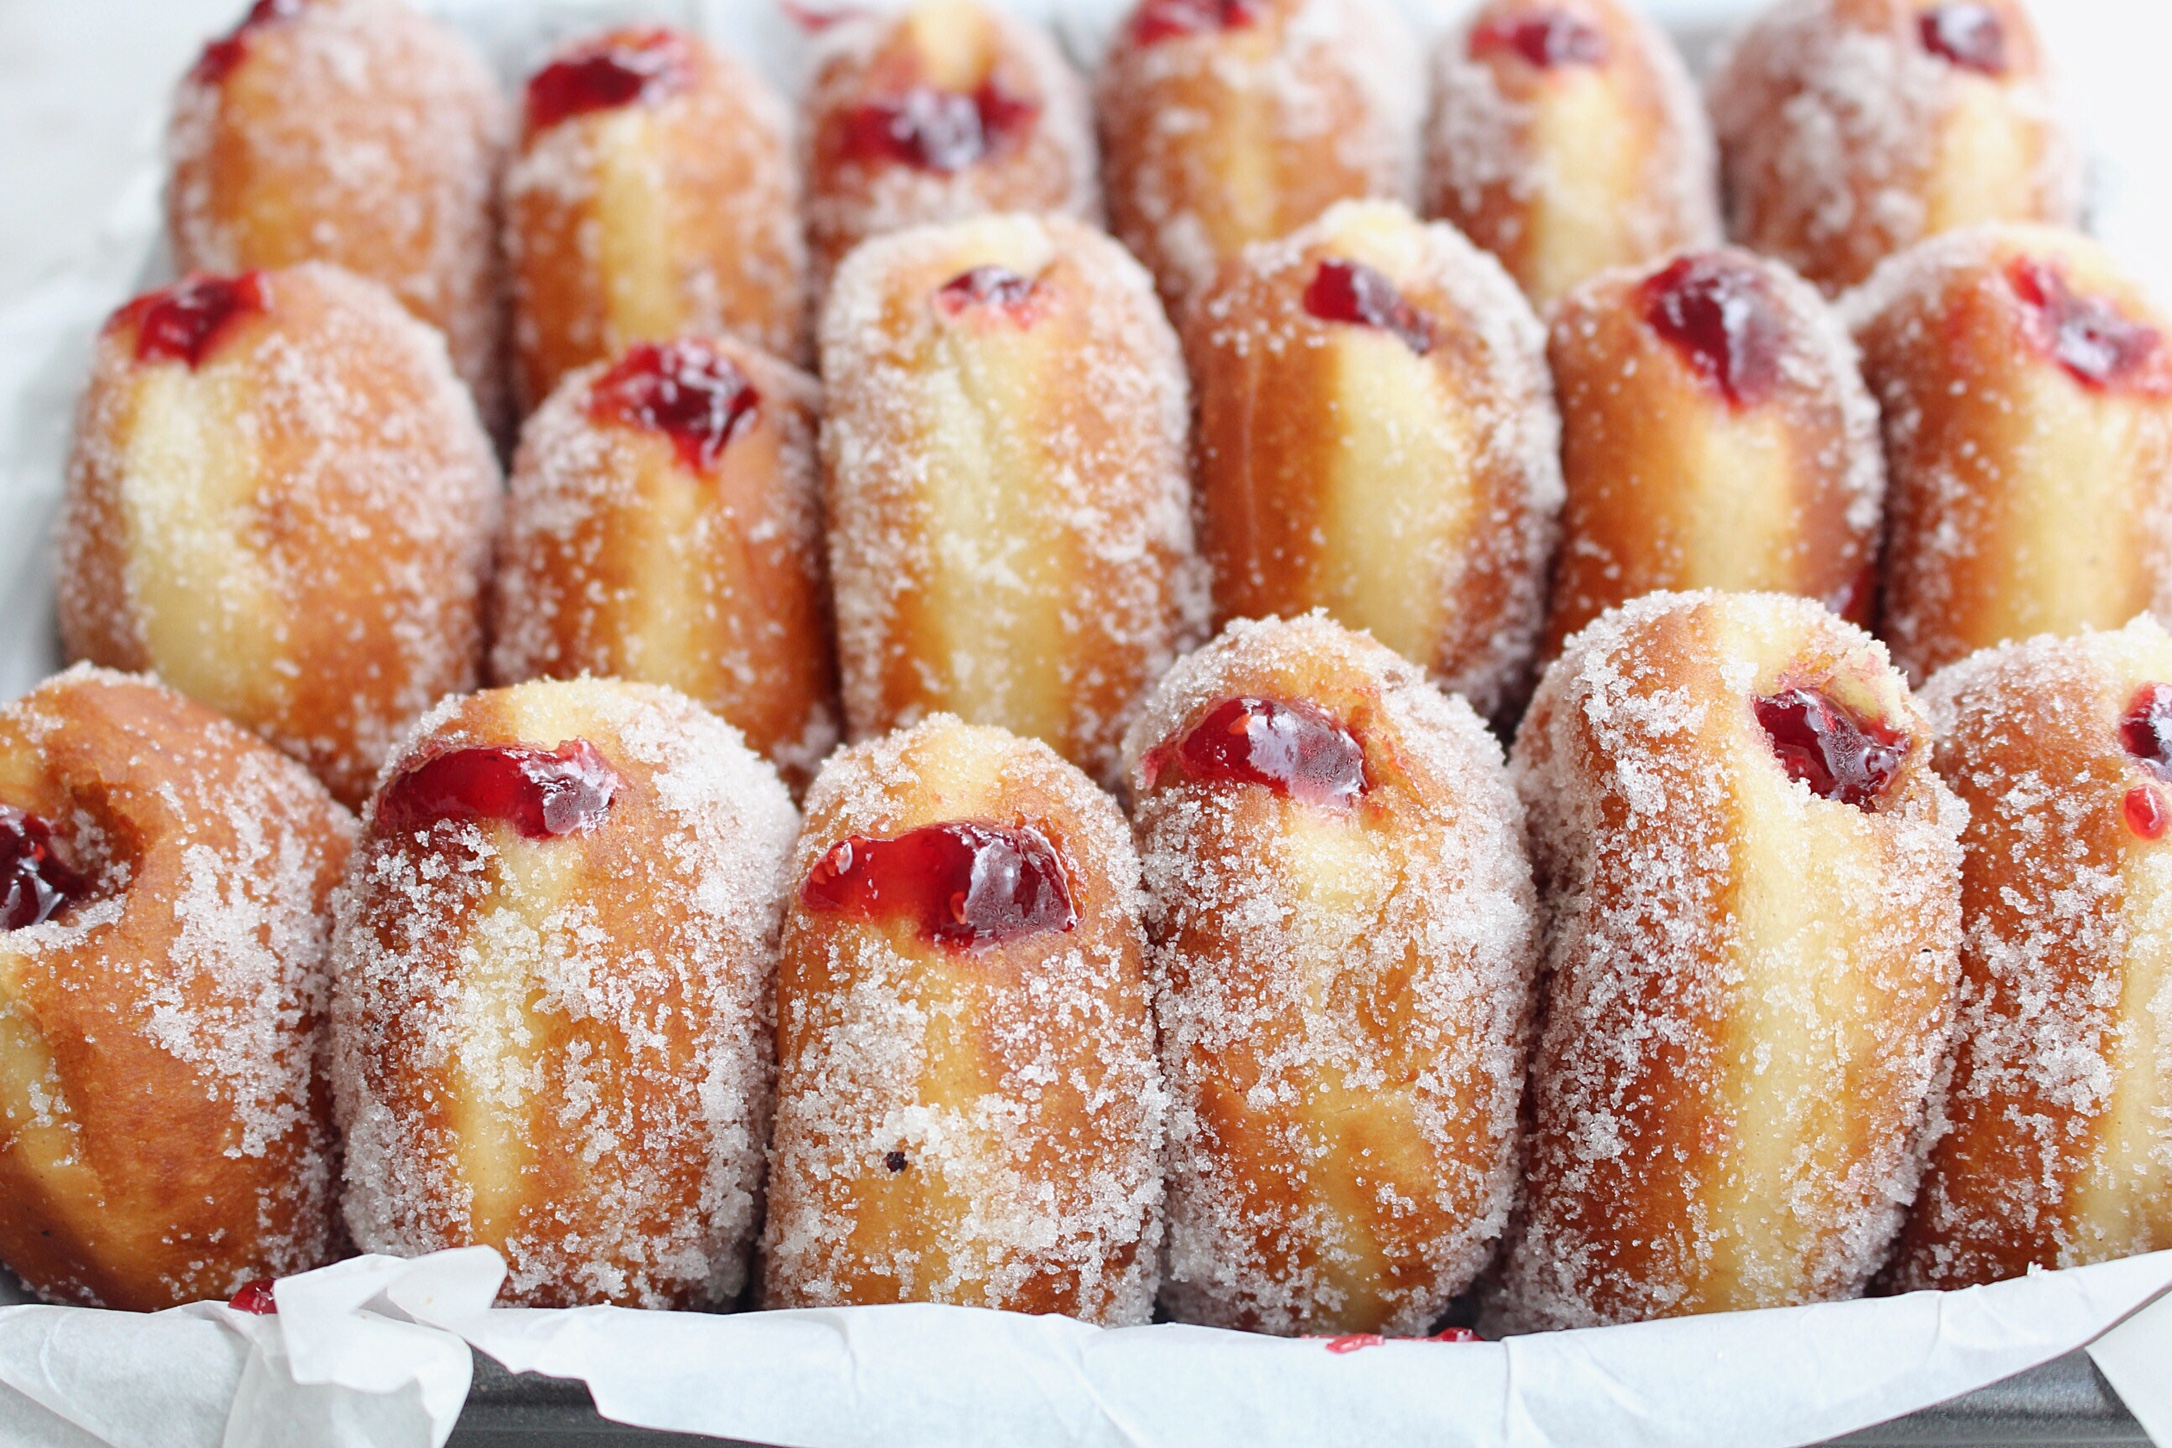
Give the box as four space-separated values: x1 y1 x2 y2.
1546 250 1885 658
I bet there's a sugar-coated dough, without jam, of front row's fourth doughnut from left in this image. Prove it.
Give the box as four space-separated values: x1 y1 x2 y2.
1125 614 1538 1335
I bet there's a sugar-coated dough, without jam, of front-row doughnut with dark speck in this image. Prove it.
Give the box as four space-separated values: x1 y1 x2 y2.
762 716 1164 1326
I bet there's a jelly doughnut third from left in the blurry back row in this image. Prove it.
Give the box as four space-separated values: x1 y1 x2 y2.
806 0 1101 280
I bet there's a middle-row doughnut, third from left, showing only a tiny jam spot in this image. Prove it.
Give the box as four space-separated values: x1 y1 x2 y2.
821 217 1205 782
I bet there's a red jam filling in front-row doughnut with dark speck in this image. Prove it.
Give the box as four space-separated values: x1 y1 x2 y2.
799 823 1079 951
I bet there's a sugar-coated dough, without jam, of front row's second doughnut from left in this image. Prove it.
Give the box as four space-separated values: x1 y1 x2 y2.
330 679 799 1307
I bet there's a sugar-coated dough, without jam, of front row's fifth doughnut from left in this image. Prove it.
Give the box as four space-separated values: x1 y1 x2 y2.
1488 593 1968 1331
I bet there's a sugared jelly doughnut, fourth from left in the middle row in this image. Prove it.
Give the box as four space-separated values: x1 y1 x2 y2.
1184 202 1562 714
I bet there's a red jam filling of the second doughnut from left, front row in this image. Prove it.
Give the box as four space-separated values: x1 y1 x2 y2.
378 738 619 840
